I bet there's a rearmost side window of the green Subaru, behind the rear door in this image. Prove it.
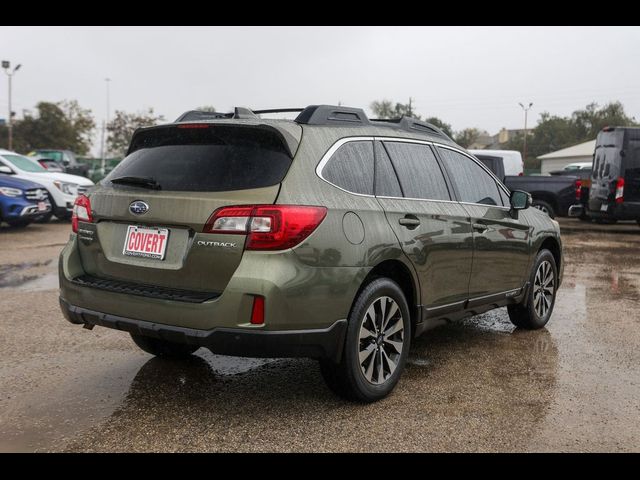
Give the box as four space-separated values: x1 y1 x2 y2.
322 141 373 195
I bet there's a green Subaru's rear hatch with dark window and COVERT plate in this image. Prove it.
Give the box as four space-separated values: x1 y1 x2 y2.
78 123 299 293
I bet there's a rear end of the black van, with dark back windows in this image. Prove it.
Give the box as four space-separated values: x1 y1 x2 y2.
589 130 624 212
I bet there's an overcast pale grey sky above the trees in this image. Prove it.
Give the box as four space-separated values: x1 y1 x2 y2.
0 27 640 153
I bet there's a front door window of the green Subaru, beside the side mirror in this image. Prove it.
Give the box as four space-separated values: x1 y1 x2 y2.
438 148 502 206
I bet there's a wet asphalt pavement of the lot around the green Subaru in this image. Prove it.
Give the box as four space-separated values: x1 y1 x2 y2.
0 219 640 452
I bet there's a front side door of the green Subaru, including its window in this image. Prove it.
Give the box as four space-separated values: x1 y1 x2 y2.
438 146 530 300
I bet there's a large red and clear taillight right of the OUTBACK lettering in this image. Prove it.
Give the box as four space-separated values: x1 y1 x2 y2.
203 205 327 250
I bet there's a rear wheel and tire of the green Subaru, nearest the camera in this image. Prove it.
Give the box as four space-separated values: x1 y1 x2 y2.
320 278 411 403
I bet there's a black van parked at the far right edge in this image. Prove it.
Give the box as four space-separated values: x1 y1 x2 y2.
589 127 640 224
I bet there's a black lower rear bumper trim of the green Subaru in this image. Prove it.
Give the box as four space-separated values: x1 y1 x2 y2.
60 297 347 362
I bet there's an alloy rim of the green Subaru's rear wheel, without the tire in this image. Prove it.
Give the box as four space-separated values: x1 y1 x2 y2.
358 297 404 385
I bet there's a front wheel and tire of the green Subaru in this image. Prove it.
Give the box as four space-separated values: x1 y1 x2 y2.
507 249 558 330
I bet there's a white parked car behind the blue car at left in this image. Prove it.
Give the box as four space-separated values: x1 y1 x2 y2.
0 149 93 219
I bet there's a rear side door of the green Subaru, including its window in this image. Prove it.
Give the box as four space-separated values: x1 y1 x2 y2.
376 140 473 314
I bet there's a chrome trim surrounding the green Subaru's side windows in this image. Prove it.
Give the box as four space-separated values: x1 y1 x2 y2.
316 136 511 210
